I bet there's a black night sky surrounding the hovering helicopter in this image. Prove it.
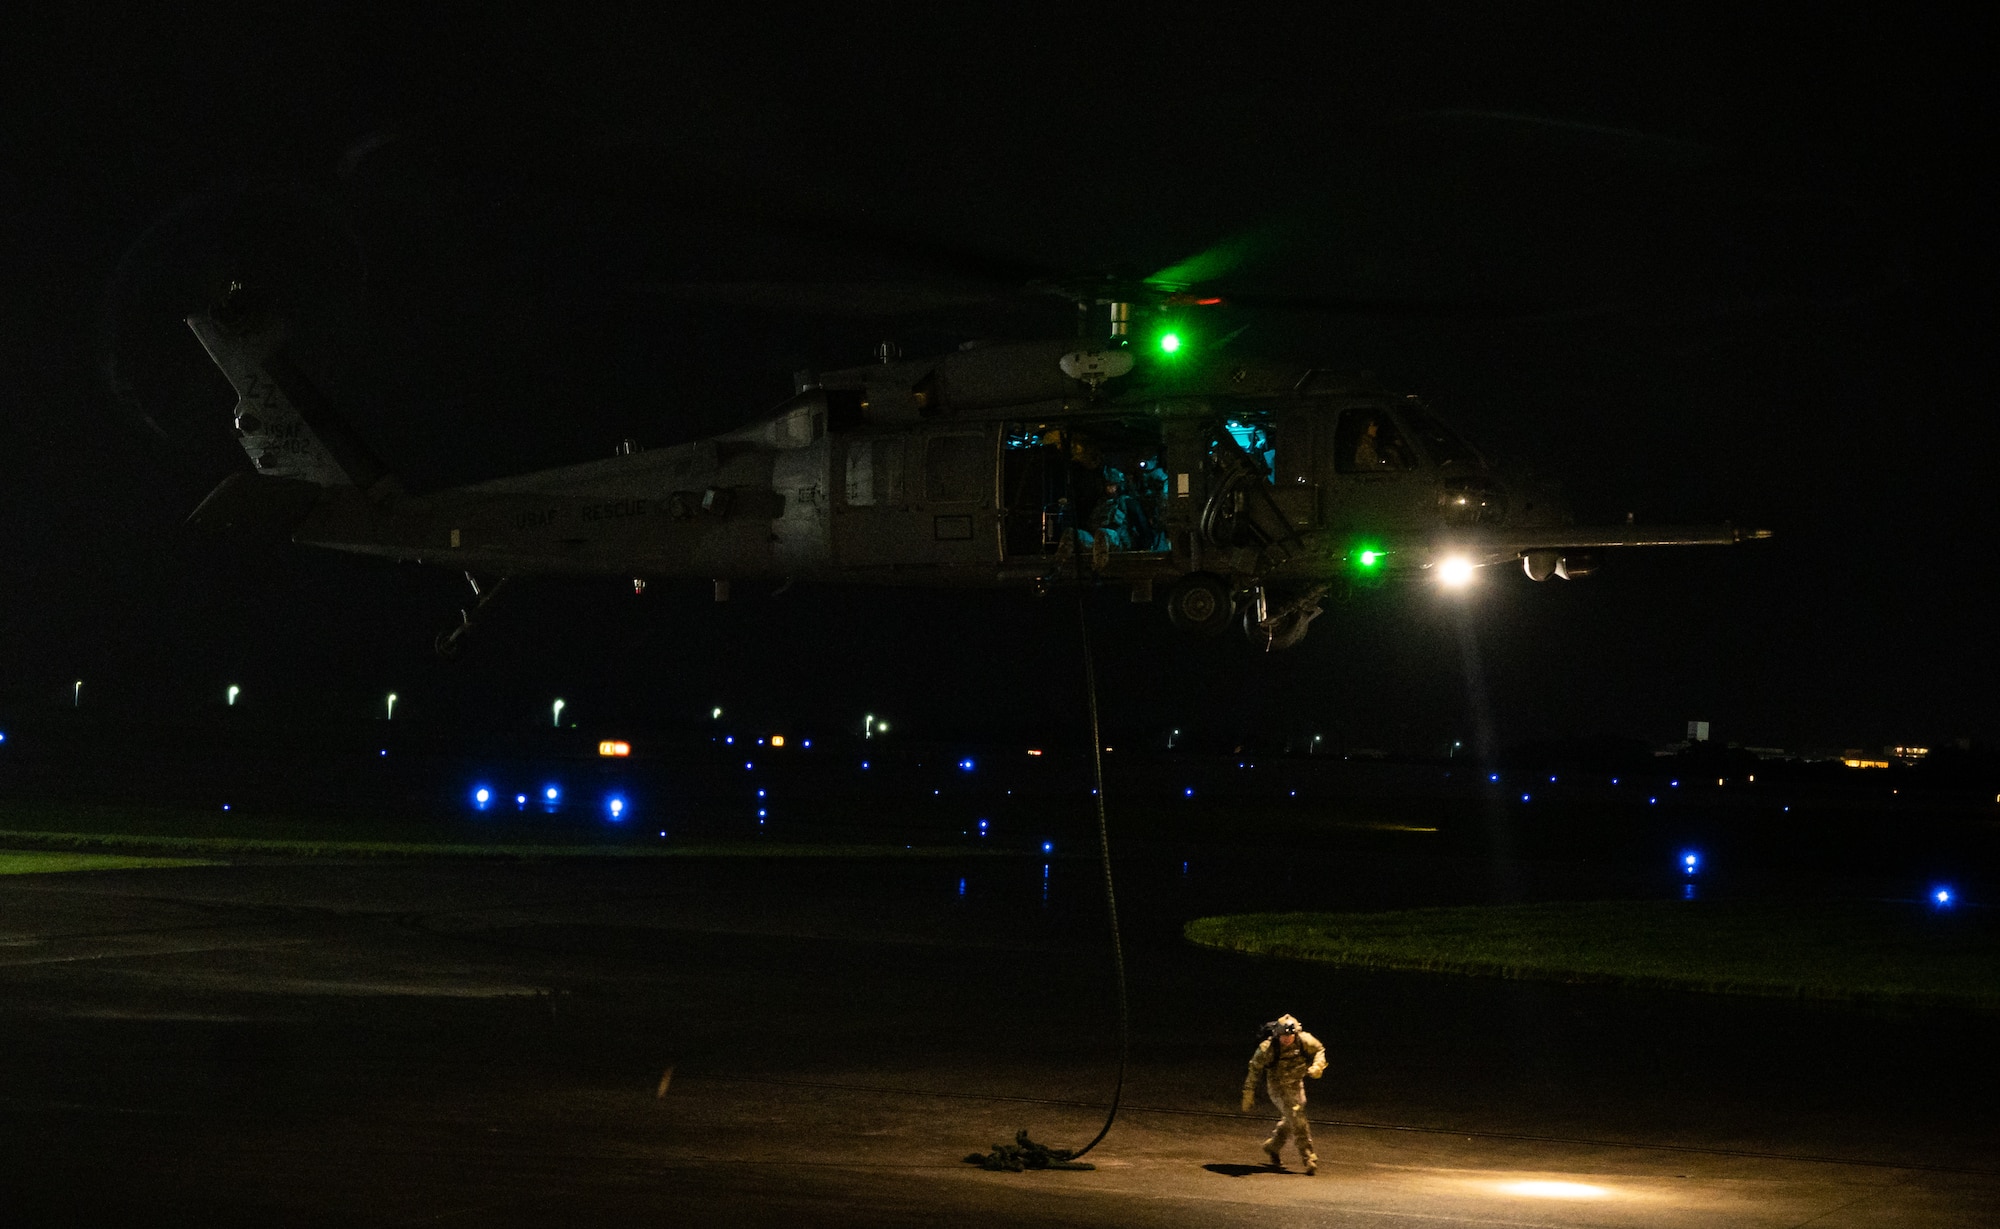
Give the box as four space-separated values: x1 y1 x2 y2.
0 2 2000 751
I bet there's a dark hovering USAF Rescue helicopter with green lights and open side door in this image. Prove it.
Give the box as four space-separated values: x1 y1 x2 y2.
186 282 1770 657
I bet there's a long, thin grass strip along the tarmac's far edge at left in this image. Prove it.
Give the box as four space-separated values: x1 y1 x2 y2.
0 829 1008 859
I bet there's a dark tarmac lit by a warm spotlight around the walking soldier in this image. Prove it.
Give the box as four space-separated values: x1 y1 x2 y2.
0 859 2000 1229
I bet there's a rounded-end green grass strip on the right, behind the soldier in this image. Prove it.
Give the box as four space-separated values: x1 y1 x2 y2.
1184 901 2000 1011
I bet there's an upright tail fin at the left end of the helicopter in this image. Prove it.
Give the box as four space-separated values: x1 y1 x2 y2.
186 288 398 498
